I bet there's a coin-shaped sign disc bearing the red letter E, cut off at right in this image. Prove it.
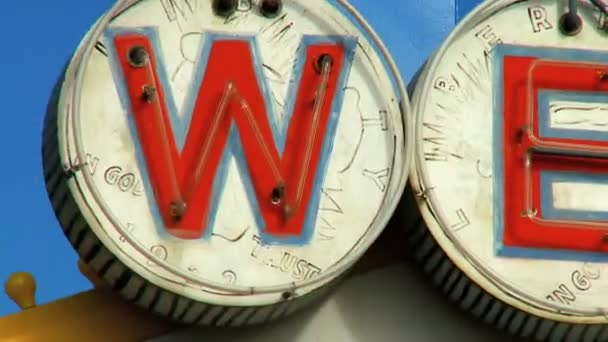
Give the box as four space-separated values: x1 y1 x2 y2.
412 0 608 341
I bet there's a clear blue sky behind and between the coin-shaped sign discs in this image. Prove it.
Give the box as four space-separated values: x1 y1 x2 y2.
0 0 479 316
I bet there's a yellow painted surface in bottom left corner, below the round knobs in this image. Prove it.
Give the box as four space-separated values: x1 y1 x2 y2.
0 290 177 342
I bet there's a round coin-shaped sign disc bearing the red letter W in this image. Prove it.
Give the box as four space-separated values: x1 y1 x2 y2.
44 0 413 325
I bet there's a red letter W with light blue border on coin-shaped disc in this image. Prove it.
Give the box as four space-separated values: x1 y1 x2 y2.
108 28 356 244
